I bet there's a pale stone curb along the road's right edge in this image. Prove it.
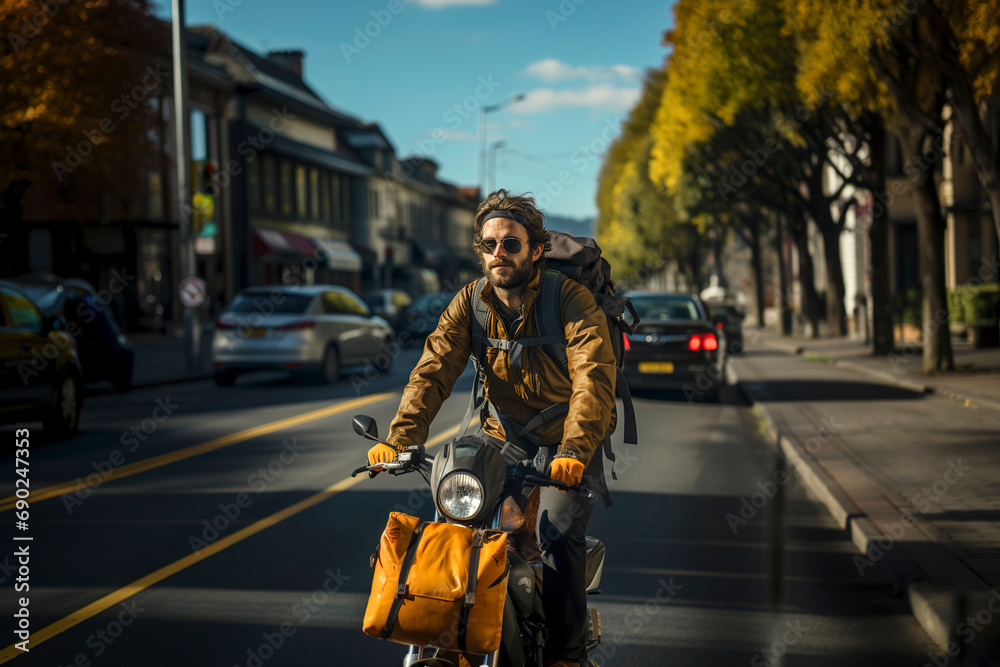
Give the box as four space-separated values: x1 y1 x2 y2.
731 368 972 664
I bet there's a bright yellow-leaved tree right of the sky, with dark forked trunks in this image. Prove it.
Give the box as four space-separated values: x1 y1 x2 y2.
651 0 864 335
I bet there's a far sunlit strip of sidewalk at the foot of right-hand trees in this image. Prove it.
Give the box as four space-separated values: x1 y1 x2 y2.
746 332 1000 410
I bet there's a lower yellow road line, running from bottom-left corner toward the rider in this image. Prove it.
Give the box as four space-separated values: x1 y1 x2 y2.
0 426 458 664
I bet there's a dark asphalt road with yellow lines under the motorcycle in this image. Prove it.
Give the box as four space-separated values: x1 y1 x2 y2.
0 350 936 667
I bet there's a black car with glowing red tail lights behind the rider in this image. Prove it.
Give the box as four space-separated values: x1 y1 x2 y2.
623 292 726 401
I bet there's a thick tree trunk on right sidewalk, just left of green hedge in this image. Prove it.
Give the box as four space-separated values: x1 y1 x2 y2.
897 126 955 373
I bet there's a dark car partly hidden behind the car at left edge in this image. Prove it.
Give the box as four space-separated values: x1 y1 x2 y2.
11 274 135 392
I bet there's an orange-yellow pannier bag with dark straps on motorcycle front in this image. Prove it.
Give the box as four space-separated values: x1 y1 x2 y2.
364 512 508 655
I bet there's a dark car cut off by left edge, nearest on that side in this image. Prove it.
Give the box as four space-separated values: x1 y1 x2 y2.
0 281 83 438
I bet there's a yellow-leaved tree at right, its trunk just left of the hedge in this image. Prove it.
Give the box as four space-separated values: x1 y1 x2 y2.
783 0 954 372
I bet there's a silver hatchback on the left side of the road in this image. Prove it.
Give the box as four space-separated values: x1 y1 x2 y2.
212 285 394 386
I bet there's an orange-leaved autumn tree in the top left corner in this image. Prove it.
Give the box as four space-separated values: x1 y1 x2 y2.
0 0 160 273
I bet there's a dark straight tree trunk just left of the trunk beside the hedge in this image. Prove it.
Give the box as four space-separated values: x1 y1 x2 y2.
868 118 894 356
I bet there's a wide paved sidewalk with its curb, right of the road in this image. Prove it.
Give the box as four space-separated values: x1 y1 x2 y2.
731 334 1000 665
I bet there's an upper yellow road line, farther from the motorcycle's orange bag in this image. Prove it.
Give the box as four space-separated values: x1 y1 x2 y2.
0 393 396 512
